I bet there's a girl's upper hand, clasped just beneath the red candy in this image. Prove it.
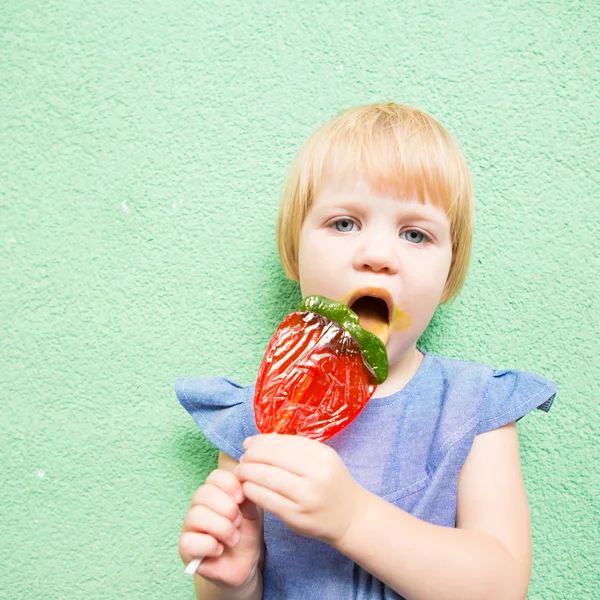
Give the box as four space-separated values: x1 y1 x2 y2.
235 434 369 547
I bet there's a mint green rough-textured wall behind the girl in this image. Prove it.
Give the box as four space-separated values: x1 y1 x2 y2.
0 0 600 600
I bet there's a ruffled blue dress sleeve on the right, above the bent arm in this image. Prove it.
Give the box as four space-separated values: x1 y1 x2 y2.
478 370 556 433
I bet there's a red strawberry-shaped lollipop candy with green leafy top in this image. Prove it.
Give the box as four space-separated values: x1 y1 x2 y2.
254 296 388 442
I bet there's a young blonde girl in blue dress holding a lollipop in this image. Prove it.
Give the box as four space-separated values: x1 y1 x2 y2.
176 103 556 600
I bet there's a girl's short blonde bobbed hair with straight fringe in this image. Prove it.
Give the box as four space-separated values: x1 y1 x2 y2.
277 102 474 303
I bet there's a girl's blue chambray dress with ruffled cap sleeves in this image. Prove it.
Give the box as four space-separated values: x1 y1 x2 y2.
175 351 556 600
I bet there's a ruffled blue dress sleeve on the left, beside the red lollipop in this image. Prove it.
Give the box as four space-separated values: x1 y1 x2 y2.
175 377 257 460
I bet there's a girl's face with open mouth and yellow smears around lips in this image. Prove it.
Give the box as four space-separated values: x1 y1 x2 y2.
298 168 452 364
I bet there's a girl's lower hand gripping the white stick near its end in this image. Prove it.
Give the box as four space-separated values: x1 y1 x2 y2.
179 469 262 588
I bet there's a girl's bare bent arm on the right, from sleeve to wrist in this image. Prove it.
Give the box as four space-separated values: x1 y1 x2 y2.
336 423 531 600
